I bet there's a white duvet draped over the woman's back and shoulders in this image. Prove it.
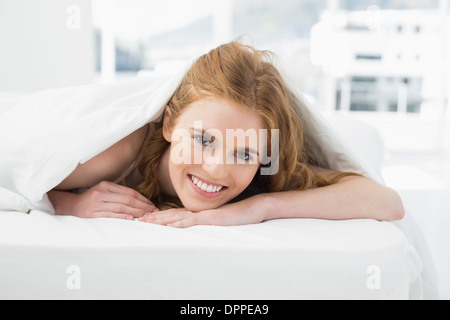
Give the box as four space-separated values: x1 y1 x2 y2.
0 63 438 298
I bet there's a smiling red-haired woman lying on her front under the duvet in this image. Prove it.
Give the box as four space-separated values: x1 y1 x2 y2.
48 42 404 227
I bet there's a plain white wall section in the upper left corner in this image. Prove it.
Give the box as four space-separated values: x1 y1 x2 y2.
0 0 95 92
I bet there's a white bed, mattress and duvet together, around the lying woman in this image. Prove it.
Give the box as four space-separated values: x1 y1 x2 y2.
0 67 432 299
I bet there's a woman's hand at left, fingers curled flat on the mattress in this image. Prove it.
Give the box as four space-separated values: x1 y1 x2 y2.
72 181 158 220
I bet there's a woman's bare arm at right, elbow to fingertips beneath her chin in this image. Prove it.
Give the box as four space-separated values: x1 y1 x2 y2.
140 168 404 227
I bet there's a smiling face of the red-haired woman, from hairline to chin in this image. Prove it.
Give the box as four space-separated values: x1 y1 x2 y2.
163 97 266 211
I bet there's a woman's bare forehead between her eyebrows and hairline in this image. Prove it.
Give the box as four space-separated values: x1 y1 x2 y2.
178 97 265 130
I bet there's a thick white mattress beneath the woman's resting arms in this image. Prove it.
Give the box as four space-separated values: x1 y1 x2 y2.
0 210 422 300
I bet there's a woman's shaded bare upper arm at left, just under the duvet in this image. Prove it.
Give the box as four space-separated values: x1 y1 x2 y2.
55 125 148 190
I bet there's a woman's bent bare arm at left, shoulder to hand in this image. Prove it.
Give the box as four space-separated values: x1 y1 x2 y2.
47 127 157 219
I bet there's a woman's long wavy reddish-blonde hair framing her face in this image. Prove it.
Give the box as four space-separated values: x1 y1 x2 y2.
136 41 355 210
